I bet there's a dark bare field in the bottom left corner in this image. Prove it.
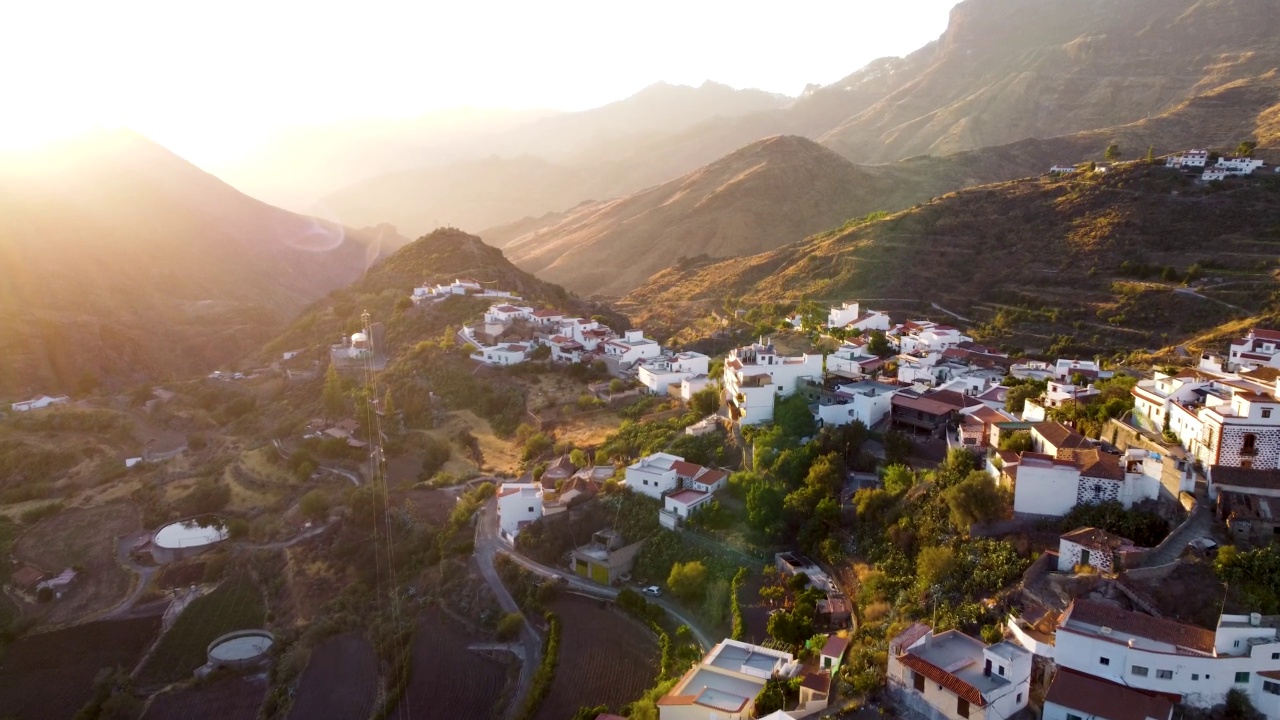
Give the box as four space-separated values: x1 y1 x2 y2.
0 615 160 720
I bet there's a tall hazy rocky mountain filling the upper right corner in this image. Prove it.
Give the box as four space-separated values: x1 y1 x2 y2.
820 0 1280 163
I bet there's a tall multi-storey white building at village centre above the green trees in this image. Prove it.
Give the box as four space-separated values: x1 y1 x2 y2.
724 343 822 425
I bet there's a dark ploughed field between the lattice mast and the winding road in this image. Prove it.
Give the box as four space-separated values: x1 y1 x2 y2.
392 610 512 720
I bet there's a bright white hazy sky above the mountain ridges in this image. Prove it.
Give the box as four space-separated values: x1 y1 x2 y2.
0 0 955 160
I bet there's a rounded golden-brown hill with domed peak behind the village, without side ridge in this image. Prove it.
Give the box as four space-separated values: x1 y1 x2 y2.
494 137 882 295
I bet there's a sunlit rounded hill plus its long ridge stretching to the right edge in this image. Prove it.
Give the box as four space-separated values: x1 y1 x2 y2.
481 73 1280 295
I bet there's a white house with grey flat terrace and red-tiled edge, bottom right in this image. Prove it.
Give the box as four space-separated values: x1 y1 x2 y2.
887 623 1032 720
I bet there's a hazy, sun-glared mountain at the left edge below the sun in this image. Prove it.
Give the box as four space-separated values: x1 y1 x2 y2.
0 133 399 395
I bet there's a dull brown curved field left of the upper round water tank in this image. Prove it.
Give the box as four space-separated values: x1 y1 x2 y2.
13 502 142 625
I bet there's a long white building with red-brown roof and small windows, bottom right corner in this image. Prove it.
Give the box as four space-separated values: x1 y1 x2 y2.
1053 600 1280 717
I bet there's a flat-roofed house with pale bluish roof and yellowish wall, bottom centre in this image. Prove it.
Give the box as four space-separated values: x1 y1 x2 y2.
658 639 831 720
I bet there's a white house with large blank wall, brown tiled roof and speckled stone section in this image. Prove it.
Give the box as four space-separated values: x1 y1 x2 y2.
1001 448 1160 518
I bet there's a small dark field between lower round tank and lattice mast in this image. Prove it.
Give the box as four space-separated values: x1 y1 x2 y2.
289 633 379 720
